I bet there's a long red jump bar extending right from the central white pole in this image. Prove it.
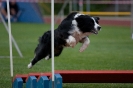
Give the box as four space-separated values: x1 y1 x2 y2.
55 70 133 83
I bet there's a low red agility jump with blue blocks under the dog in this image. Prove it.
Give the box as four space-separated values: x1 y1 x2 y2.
13 70 133 88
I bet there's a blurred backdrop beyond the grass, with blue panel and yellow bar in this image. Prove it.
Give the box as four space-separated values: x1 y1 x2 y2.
1 0 132 25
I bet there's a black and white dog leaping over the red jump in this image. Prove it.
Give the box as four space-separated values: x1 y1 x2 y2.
28 12 101 68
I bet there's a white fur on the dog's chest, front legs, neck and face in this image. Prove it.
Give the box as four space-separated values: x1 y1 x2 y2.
66 14 91 52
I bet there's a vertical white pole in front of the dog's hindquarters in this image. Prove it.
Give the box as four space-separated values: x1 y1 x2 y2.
51 0 54 88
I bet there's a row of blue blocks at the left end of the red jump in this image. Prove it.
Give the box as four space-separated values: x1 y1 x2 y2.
13 74 62 88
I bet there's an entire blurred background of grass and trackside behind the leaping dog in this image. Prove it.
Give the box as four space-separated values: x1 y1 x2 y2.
0 0 133 88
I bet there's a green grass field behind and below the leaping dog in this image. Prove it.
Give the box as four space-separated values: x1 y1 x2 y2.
0 23 133 88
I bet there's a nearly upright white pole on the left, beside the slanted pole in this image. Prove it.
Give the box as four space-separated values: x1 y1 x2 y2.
7 0 13 78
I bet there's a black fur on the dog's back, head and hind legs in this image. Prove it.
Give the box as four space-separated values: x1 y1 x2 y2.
28 12 100 68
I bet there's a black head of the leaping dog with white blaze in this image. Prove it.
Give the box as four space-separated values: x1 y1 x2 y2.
74 13 101 34
